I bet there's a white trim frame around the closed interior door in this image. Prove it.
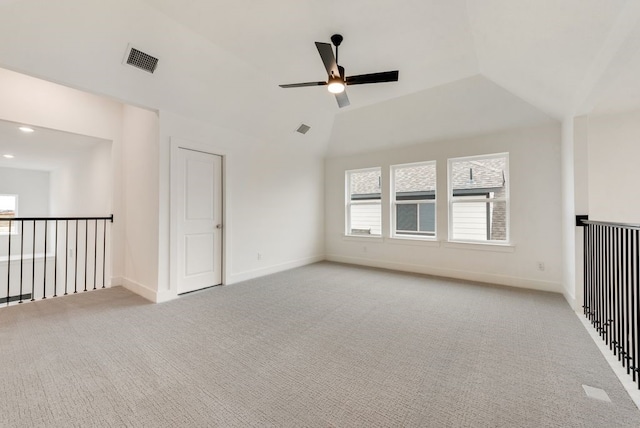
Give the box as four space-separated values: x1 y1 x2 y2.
169 137 230 297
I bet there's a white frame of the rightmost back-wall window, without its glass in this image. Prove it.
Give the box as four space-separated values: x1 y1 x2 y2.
447 152 511 245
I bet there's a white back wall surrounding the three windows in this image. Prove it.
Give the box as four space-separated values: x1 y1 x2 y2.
325 126 563 292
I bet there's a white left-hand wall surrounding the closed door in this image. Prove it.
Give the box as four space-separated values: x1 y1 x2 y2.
0 63 324 300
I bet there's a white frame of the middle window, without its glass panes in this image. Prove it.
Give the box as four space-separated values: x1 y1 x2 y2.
389 160 438 241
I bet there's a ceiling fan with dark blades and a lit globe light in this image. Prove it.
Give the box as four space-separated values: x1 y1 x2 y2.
280 34 398 108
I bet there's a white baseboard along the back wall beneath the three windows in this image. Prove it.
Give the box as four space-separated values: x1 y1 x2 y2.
326 254 562 293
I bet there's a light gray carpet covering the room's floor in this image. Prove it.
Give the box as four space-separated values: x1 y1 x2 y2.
0 263 640 427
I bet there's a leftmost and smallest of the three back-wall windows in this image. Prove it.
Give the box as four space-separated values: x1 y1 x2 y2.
346 168 382 236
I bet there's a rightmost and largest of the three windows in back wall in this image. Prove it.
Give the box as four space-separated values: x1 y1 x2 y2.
449 153 509 243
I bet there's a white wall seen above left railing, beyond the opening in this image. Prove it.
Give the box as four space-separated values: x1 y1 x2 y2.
50 141 113 217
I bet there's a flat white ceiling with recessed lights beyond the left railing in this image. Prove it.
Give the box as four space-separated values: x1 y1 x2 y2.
0 120 110 171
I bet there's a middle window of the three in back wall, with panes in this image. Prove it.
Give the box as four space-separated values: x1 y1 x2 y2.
391 162 436 237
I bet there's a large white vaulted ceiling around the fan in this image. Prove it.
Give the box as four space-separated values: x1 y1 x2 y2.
0 0 640 154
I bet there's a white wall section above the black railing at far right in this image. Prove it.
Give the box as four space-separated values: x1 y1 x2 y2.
588 110 640 224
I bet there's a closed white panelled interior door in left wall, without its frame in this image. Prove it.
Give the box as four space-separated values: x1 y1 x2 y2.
176 148 222 293
